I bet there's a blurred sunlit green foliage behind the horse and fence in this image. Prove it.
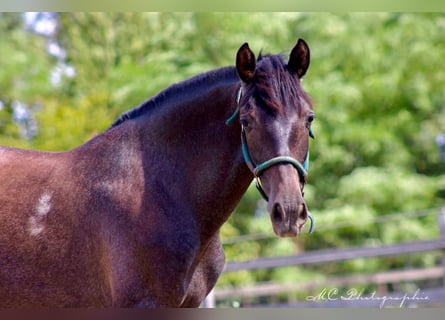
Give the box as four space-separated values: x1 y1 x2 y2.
0 12 445 307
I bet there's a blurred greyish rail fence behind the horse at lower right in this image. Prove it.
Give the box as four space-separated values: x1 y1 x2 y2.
204 208 445 308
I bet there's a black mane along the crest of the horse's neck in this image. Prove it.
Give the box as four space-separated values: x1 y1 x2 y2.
110 67 238 129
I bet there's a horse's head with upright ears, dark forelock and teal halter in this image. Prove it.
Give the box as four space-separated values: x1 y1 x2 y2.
236 39 315 237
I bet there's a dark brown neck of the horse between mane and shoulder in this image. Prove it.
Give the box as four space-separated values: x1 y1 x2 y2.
134 83 252 238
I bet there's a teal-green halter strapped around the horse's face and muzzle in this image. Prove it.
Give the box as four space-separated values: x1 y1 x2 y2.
226 88 315 233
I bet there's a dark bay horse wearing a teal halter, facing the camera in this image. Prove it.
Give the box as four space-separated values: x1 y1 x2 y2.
0 39 314 307
